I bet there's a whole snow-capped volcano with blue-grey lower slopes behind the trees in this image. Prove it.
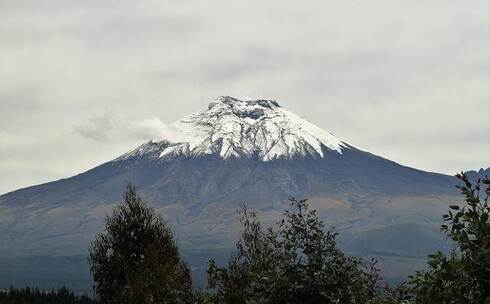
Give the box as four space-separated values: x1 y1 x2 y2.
0 96 468 290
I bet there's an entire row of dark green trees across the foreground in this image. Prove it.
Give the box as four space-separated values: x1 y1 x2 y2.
0 173 490 304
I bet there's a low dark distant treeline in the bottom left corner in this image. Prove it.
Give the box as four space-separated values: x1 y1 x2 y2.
0 287 97 304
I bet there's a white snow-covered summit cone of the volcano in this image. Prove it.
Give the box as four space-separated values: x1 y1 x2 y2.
123 96 350 161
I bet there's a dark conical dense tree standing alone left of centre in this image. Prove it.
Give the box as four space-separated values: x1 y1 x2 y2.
89 184 192 304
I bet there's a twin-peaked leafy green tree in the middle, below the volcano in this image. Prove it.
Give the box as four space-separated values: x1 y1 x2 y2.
208 199 378 304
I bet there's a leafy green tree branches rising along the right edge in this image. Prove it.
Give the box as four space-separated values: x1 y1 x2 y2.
410 173 490 304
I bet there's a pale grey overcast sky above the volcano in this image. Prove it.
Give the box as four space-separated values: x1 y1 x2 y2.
0 0 490 193
